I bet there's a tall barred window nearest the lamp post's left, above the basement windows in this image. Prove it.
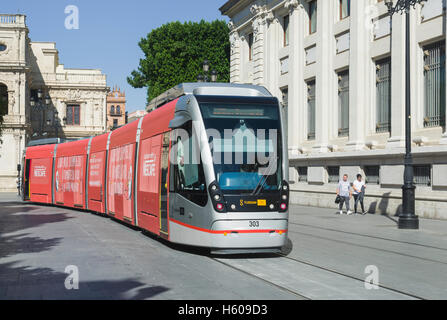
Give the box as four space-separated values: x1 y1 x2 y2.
376 58 391 133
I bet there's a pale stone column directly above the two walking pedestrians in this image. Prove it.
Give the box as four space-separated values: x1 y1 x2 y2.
346 0 371 150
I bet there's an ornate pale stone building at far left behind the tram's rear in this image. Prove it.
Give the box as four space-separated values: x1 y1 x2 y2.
0 14 108 191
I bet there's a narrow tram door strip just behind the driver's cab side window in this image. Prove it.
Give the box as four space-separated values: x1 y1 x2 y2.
160 132 170 235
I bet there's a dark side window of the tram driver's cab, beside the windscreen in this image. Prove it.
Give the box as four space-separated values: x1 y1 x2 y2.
173 121 208 206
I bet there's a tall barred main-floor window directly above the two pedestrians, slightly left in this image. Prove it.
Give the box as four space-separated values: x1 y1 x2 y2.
338 70 349 137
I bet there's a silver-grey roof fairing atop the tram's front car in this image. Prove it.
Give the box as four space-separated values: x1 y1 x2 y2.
147 82 272 112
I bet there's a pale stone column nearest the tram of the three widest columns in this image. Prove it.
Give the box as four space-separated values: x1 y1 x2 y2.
313 1 337 152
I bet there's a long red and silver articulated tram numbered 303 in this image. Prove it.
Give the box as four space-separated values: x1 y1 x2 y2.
22 83 289 253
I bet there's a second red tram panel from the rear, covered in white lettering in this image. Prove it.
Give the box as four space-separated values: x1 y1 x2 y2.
54 140 89 209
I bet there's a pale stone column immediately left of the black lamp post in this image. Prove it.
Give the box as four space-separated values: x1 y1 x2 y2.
387 14 406 148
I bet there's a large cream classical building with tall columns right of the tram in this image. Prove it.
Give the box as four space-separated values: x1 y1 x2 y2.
220 0 447 219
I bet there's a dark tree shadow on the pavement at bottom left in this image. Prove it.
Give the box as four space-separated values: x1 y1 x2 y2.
0 202 170 300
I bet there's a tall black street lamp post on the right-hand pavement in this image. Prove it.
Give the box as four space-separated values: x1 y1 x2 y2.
385 0 427 230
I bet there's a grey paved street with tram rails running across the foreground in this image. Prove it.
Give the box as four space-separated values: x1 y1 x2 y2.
0 195 447 300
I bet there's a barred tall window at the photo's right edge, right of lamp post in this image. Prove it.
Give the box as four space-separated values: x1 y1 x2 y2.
424 41 446 127
